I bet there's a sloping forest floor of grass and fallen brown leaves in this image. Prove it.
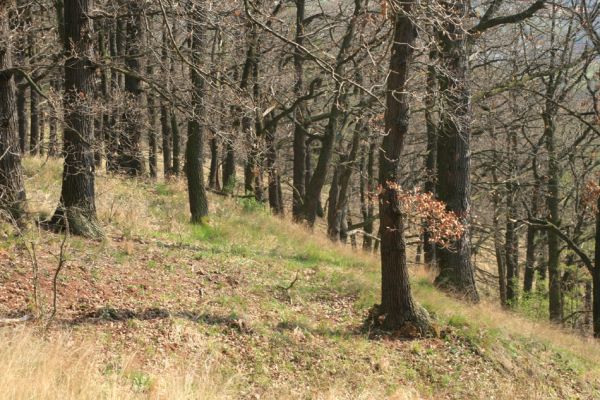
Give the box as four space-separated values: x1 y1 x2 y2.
0 159 600 399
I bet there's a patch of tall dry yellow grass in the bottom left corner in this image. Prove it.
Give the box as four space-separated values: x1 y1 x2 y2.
0 327 229 400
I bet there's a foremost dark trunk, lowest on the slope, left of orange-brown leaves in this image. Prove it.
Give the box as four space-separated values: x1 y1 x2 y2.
372 2 429 334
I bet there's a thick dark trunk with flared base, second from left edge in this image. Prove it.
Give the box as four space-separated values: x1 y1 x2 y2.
50 0 103 238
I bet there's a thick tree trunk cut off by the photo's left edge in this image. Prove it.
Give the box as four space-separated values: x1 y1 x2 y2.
0 7 26 222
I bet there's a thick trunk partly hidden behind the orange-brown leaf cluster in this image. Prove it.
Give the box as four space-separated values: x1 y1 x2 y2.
436 0 479 302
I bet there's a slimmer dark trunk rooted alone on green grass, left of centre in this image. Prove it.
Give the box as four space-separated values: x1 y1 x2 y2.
185 1 208 224
